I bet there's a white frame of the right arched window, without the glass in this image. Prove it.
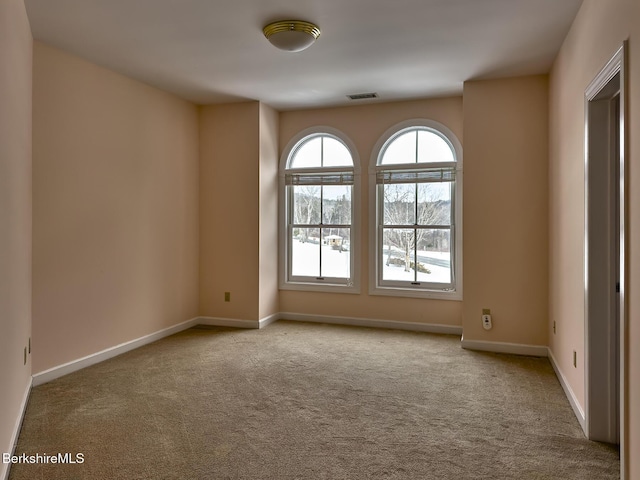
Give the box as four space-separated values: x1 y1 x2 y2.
369 118 463 300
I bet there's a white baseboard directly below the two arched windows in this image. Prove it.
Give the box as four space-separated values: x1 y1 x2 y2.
279 312 462 335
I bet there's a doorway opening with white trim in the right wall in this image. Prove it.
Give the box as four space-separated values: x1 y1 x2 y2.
585 46 626 478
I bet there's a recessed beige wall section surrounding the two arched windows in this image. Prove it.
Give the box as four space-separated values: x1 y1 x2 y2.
280 97 462 326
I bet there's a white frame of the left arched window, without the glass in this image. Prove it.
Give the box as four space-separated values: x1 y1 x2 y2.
278 126 362 294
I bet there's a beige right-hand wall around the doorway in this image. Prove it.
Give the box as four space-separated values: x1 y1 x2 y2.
549 0 640 479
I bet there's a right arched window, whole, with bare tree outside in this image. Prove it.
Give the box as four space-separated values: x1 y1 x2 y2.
370 120 462 299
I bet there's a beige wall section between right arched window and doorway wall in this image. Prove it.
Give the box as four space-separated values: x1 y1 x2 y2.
463 76 548 345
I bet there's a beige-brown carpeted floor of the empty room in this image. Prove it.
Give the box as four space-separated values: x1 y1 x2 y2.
9 321 619 480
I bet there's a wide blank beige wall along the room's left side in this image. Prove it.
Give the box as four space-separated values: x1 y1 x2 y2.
33 42 198 373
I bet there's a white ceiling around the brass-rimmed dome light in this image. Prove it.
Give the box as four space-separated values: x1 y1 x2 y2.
25 0 582 110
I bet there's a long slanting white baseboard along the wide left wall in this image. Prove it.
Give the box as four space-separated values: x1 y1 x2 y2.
33 317 198 387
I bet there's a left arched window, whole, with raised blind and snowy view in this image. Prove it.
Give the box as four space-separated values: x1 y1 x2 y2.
280 127 360 293
